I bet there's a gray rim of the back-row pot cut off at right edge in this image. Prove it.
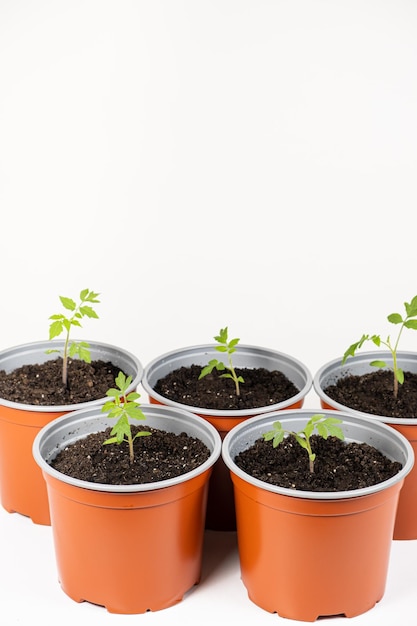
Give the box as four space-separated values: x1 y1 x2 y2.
313 350 417 426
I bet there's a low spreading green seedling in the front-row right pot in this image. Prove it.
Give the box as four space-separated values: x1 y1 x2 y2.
263 413 345 473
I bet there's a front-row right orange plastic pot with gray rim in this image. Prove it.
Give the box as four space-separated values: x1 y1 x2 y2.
222 409 414 622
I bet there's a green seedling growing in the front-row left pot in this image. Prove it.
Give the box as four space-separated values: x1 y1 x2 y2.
102 372 151 463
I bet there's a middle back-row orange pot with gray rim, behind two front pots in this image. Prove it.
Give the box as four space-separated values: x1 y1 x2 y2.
142 344 313 531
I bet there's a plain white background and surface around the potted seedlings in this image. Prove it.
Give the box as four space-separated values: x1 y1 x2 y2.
0 0 417 626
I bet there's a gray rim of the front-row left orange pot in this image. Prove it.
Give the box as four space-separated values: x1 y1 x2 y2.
32 404 222 494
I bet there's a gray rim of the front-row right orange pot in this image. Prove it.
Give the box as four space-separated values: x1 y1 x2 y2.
222 409 414 502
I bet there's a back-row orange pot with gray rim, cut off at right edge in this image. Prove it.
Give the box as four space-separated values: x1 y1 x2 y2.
313 350 417 540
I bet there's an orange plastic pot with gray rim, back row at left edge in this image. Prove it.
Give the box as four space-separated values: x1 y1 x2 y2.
0 341 143 525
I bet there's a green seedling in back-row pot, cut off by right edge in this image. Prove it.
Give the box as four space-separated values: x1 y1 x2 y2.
342 296 417 398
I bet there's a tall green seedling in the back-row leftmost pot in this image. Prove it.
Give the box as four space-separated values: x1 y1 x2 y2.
47 289 100 387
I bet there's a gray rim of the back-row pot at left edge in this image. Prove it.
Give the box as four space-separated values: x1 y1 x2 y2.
0 339 143 413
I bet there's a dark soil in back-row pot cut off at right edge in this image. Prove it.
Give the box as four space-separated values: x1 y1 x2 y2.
323 370 417 418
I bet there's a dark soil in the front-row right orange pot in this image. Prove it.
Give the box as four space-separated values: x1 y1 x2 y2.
234 435 402 491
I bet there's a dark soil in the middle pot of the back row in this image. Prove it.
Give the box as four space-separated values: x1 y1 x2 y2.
155 365 300 410
